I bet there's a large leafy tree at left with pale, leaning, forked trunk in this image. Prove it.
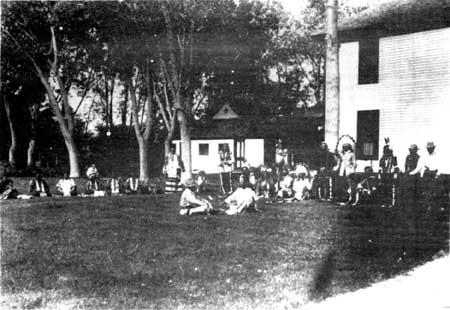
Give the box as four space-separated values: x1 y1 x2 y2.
2 2 96 177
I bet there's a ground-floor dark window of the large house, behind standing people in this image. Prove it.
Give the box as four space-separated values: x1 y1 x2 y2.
356 110 380 160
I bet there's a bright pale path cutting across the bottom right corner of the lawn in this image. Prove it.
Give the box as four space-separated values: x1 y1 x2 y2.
302 255 450 310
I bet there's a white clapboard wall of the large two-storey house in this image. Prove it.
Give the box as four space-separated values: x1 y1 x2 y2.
339 28 450 173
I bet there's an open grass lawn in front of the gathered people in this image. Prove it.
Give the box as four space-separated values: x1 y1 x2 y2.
0 196 449 309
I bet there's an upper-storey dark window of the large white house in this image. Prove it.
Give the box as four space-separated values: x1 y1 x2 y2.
358 39 379 84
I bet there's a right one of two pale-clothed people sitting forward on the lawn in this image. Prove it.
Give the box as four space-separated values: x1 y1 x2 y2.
224 174 262 215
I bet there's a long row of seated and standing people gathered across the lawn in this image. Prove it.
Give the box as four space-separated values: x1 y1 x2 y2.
0 141 439 215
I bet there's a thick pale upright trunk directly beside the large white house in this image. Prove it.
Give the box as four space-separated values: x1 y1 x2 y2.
325 0 339 147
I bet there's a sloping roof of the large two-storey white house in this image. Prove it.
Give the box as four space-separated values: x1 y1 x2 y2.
313 0 450 41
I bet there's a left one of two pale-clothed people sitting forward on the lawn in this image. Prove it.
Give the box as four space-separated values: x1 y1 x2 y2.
180 179 213 215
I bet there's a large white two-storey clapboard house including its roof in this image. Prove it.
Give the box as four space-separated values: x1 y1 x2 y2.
326 0 450 173
